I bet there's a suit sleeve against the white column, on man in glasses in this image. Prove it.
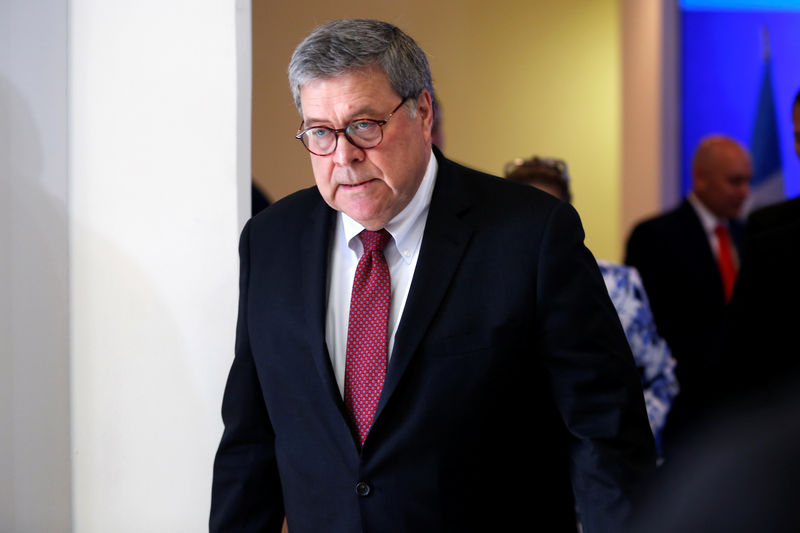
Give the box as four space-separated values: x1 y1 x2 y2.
209 222 284 533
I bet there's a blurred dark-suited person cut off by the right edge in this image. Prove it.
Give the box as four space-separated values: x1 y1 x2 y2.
631 92 800 533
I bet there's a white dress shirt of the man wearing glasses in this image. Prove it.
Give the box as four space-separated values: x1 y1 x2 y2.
325 153 438 397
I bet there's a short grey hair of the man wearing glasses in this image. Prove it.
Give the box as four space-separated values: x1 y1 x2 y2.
289 19 433 114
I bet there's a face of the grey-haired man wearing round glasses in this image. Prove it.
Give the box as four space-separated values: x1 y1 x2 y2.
300 67 432 231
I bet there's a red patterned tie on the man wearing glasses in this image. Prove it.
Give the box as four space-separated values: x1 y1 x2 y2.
344 229 392 445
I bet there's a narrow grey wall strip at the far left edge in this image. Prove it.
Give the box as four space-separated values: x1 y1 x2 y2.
0 0 70 533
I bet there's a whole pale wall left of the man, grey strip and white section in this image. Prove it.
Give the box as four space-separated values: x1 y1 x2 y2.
0 0 250 533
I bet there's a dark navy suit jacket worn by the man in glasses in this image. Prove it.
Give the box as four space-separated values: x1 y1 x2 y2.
211 150 654 533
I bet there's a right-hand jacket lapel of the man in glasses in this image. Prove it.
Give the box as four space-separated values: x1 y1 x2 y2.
375 150 472 418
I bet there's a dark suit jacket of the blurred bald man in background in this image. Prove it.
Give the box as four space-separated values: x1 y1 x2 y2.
625 200 744 456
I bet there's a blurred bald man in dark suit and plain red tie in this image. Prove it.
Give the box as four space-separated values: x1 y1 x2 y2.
625 136 752 460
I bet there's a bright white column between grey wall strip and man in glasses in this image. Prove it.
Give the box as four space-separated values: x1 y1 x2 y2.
69 0 250 533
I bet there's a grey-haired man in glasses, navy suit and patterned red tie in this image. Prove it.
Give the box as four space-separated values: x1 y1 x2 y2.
210 20 654 533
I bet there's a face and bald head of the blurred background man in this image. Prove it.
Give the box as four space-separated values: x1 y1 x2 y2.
694 144 753 218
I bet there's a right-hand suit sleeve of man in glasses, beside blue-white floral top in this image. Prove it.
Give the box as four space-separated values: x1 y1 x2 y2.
537 203 655 533
